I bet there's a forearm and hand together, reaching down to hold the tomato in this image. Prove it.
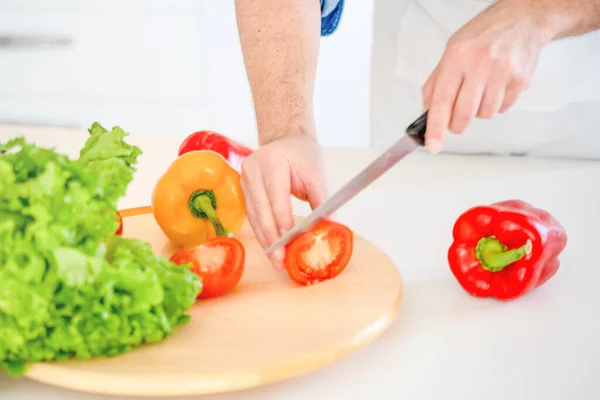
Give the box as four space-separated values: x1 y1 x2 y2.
235 0 326 269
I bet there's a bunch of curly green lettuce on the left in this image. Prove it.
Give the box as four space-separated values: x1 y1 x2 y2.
0 123 202 377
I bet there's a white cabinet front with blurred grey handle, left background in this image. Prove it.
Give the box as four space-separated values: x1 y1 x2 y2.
0 0 210 134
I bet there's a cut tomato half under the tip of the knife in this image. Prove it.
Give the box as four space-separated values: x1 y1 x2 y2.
284 220 354 285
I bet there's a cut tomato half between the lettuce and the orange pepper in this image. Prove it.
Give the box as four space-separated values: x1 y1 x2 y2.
170 236 246 299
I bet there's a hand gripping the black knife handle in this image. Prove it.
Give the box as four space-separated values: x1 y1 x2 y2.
423 0 550 153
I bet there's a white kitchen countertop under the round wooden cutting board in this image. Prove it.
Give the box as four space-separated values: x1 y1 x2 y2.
0 126 600 400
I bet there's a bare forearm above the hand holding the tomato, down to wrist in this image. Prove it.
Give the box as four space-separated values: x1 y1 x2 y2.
235 0 321 144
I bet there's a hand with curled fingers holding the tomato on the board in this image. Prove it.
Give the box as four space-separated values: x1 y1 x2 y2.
242 134 327 270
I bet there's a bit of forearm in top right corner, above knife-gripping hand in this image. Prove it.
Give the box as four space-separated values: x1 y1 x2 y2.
505 0 600 41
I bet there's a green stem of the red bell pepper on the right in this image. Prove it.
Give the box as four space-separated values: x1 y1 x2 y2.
475 237 533 272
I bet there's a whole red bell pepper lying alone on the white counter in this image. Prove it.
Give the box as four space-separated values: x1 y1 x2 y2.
448 200 567 300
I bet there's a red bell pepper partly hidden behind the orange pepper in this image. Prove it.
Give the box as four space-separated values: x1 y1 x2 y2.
178 131 254 173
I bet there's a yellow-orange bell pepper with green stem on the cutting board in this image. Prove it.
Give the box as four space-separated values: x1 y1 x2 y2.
152 150 246 247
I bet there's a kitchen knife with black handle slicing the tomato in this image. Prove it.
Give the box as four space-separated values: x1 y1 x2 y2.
265 111 428 254
